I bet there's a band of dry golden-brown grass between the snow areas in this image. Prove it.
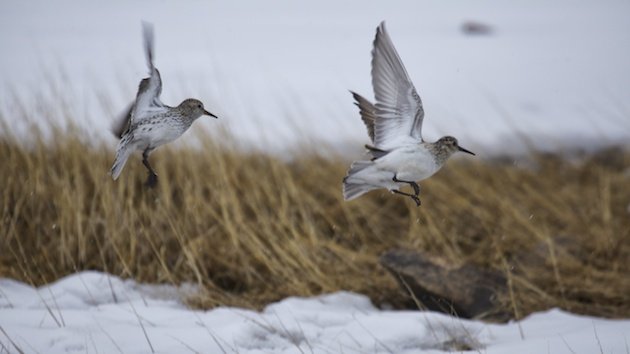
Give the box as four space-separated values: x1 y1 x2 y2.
0 109 630 317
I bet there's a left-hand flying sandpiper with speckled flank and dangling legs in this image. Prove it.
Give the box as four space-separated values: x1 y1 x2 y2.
110 23 217 187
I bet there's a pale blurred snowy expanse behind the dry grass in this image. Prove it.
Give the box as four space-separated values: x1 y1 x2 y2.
0 0 630 153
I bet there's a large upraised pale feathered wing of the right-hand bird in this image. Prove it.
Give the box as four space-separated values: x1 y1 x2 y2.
372 21 424 150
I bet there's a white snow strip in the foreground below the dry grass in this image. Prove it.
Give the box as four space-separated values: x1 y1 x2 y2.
0 272 630 354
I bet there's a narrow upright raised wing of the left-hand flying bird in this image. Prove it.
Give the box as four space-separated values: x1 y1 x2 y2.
131 22 164 123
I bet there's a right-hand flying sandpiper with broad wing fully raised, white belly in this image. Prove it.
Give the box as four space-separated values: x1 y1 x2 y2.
343 21 474 206
